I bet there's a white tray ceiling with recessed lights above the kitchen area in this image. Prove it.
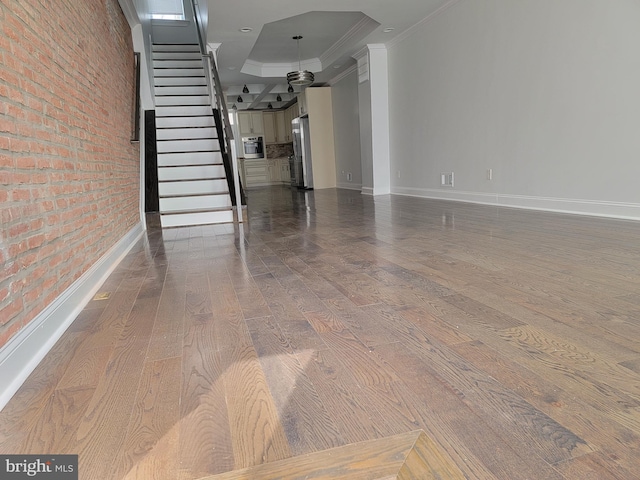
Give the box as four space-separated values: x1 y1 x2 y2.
207 0 451 110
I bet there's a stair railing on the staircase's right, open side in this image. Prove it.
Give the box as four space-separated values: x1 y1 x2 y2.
191 0 243 223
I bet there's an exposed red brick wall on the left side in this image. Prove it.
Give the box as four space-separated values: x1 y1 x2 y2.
0 0 140 347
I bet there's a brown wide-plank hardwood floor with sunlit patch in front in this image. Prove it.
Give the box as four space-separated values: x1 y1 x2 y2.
0 187 640 480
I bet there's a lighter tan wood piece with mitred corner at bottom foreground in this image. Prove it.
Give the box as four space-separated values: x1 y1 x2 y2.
199 430 465 480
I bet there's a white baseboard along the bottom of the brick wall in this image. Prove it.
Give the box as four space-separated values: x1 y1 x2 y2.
0 223 144 410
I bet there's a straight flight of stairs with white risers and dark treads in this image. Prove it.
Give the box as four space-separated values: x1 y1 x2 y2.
153 44 234 228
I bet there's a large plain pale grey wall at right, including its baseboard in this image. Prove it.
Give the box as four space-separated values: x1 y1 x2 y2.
388 0 640 218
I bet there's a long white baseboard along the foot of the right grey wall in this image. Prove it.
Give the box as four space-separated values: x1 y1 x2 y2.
391 187 640 220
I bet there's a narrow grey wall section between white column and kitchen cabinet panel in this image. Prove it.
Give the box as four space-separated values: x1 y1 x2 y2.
331 70 362 190
